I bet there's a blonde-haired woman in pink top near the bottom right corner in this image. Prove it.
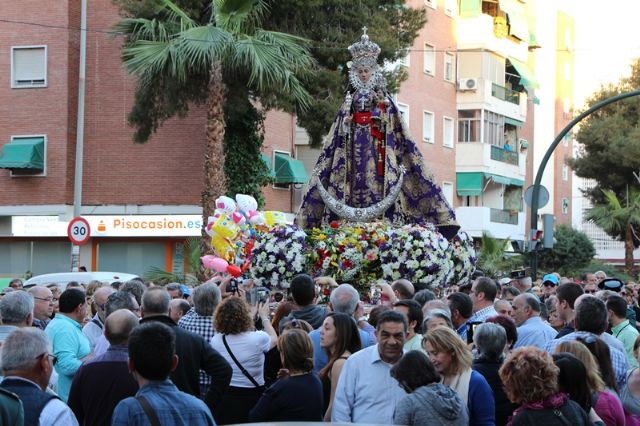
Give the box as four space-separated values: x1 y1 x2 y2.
556 340 625 426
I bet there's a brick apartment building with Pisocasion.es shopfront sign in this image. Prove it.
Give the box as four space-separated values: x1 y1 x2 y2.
0 0 295 276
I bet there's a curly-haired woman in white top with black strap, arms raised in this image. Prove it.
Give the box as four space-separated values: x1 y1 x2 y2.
211 296 278 425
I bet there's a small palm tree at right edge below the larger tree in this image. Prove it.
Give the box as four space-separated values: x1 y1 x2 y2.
585 187 640 276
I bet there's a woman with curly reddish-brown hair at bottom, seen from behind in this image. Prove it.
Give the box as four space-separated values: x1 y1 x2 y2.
500 346 590 426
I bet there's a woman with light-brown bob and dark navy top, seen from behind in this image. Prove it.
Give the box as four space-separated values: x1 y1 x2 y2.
249 328 323 422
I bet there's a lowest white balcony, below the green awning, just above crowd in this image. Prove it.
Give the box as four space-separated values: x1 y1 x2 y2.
456 207 526 240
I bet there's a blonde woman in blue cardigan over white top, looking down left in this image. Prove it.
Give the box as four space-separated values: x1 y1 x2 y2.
422 327 495 425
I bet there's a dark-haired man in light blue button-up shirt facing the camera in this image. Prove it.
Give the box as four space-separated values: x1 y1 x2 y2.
331 311 407 424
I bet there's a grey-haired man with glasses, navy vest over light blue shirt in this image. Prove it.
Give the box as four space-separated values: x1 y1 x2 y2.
0 327 78 426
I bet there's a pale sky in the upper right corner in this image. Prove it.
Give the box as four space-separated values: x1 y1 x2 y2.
559 0 640 108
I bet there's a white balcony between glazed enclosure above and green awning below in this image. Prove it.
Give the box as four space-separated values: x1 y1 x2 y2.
456 142 526 181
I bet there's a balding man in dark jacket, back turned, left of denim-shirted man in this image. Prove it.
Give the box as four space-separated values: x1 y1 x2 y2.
69 310 139 426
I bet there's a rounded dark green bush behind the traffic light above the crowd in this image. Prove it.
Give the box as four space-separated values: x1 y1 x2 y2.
539 225 596 276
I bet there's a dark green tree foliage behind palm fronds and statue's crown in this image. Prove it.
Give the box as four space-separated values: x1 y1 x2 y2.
113 0 426 148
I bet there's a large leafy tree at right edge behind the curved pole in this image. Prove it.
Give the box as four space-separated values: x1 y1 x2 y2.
568 59 640 218
